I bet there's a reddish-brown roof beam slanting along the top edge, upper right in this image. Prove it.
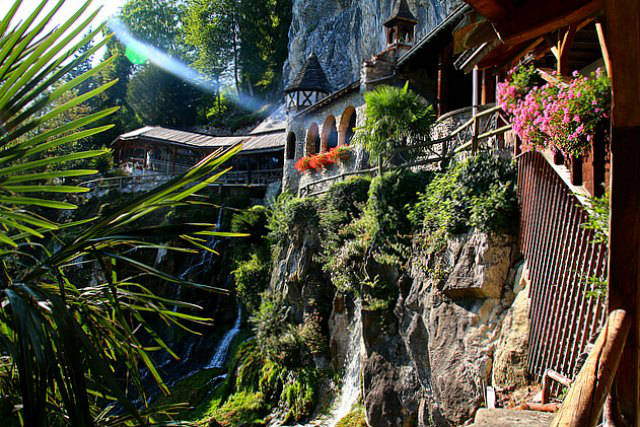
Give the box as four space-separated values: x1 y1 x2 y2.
496 0 604 44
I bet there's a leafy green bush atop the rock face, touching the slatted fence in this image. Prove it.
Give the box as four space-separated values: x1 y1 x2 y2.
409 153 518 252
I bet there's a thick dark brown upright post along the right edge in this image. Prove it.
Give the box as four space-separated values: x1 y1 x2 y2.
605 0 640 426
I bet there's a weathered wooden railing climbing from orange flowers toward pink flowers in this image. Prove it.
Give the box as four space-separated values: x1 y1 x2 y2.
298 106 511 197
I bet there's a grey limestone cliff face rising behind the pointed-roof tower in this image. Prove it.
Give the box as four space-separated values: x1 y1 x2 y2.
284 0 461 90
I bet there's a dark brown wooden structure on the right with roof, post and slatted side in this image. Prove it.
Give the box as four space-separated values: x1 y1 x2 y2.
454 0 640 426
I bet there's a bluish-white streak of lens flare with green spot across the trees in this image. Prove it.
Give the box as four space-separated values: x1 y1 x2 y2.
107 19 265 111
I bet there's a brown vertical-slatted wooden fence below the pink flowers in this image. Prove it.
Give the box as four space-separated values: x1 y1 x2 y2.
518 152 608 391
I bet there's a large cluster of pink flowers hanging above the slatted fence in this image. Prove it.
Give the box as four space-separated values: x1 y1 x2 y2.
498 66 611 158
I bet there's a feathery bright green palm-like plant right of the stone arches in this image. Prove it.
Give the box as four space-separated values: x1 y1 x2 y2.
355 82 435 162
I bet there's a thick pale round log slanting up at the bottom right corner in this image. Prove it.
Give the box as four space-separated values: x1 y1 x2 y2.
551 310 631 427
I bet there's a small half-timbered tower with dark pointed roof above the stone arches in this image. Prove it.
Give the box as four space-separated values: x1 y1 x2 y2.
284 50 332 113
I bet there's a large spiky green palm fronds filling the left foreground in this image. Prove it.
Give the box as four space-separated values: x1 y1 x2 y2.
0 0 245 427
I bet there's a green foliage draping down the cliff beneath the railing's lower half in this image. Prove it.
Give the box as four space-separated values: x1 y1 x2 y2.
321 171 431 309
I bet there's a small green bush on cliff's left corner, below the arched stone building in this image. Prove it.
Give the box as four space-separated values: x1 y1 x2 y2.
267 192 319 243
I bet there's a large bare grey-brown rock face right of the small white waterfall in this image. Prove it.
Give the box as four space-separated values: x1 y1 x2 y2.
363 233 518 427
